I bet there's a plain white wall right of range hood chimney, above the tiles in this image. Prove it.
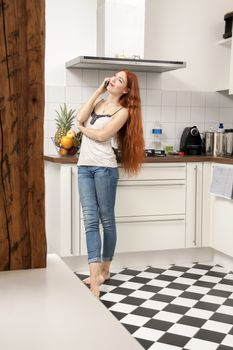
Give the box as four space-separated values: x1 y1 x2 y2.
145 0 233 91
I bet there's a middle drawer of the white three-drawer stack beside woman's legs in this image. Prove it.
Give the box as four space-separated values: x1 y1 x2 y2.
115 181 185 217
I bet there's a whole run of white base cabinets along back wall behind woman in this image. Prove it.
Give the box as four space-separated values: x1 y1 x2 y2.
45 161 218 257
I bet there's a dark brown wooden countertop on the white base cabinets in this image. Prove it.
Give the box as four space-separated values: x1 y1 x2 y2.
44 155 233 164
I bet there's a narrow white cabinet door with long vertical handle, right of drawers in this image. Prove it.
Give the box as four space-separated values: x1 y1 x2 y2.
185 162 203 248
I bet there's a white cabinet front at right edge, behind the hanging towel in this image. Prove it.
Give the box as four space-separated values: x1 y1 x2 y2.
210 163 233 257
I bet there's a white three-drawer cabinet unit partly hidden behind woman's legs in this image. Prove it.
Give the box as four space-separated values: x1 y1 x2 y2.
81 163 186 255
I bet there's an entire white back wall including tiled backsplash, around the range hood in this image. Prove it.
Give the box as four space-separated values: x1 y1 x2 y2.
44 0 233 154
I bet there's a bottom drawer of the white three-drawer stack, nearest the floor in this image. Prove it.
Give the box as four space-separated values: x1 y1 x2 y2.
81 215 185 255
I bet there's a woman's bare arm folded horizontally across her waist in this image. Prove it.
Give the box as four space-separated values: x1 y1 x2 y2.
78 108 128 142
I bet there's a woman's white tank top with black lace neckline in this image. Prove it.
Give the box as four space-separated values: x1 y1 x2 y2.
77 107 123 168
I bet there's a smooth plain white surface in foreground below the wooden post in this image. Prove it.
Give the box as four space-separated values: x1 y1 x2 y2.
0 254 142 350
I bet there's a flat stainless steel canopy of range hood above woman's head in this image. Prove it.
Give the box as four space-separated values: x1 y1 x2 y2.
66 56 186 73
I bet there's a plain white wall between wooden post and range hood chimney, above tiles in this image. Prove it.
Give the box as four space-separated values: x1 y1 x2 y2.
45 0 97 85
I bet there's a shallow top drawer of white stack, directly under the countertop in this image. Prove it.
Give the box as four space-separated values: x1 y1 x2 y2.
119 163 186 181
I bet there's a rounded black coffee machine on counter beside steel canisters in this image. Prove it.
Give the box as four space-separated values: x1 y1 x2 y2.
180 126 202 156
